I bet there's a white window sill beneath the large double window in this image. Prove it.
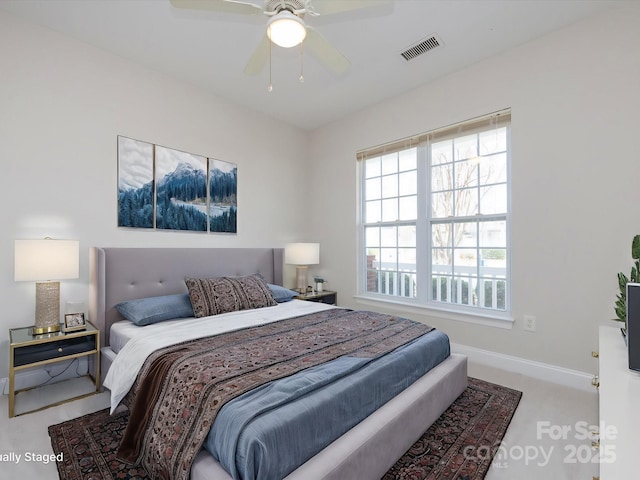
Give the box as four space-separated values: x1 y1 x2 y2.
353 295 513 330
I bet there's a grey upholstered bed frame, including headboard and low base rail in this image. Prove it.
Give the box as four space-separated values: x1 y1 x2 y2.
89 247 467 480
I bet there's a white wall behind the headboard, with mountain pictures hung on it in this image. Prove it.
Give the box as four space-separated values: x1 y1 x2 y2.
0 12 308 377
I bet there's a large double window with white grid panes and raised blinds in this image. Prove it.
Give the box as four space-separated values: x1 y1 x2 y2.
359 110 511 316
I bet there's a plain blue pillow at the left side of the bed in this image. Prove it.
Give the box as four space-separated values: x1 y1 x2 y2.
116 293 194 326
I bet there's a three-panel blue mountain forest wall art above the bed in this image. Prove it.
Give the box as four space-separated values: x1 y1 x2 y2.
118 136 238 233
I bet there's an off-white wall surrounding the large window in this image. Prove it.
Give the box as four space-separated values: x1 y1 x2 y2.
309 3 640 373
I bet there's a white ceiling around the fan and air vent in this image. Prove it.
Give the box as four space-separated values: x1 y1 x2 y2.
0 0 617 129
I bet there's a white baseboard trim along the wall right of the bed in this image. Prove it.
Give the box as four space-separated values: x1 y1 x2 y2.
451 343 593 392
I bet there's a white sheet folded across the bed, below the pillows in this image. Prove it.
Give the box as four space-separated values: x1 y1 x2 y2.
104 300 336 413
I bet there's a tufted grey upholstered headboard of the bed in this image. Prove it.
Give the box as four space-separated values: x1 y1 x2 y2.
89 247 283 346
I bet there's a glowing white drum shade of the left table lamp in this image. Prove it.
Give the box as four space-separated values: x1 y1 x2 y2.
14 239 80 282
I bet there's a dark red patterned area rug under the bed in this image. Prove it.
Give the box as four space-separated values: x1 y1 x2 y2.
49 377 522 480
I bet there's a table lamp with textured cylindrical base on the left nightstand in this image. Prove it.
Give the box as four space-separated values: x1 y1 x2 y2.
14 238 80 335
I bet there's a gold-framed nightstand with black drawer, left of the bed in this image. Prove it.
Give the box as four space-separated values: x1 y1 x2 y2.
9 322 100 418
